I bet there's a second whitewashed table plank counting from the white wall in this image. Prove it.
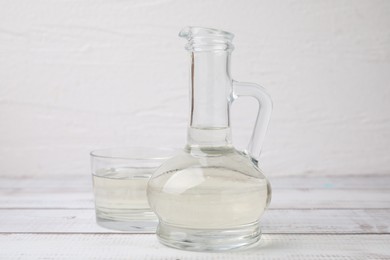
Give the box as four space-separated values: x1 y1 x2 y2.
0 188 390 209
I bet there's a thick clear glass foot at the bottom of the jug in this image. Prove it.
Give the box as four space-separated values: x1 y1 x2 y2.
156 221 261 251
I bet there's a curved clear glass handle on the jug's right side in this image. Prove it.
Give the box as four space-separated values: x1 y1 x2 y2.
232 80 272 163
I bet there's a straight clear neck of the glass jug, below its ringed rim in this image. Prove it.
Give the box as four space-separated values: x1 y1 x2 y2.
187 50 232 147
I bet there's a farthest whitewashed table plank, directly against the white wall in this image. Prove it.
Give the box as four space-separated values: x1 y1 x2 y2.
0 173 390 191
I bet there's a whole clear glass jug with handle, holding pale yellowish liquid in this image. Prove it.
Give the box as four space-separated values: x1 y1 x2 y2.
147 27 272 251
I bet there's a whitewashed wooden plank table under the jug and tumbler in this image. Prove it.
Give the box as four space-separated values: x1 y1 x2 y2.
0 175 390 259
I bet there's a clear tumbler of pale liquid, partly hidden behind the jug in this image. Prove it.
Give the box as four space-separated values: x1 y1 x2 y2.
90 147 174 233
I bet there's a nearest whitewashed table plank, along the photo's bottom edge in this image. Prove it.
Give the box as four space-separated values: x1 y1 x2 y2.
0 234 390 260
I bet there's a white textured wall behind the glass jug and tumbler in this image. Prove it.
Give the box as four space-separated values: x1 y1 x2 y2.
0 0 390 176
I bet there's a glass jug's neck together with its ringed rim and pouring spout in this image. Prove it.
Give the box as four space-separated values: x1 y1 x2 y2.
179 27 234 148
